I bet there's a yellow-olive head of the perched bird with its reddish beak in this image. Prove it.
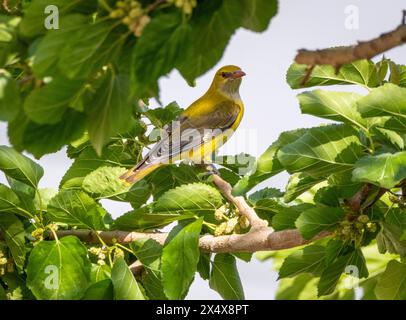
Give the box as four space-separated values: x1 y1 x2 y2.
211 65 245 97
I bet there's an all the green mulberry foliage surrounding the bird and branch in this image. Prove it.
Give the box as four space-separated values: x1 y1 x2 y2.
0 0 406 300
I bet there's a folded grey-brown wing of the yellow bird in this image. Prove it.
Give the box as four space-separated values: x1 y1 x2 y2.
137 100 241 167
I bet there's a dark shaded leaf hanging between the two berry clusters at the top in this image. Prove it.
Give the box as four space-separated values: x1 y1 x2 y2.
131 10 191 97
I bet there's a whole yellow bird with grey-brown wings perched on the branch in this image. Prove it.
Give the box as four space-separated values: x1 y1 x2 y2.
120 65 245 183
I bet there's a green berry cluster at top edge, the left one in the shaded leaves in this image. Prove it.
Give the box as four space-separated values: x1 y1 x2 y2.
110 0 151 37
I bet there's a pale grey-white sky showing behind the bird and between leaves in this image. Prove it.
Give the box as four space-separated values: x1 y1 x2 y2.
0 0 406 299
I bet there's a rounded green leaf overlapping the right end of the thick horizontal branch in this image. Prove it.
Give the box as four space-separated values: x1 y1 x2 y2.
295 206 345 240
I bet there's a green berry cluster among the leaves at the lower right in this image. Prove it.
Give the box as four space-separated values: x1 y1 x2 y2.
335 214 377 244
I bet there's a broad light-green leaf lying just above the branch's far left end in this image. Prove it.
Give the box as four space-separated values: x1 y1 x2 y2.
47 190 109 230
